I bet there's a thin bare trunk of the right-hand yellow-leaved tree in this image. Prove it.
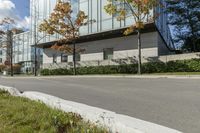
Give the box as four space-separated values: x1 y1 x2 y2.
138 29 142 74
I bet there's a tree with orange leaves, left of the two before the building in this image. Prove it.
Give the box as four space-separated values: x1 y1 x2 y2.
39 0 87 75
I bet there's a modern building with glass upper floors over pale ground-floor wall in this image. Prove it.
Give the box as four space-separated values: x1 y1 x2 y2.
24 0 173 68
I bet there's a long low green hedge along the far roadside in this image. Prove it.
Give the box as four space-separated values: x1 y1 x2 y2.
41 59 200 75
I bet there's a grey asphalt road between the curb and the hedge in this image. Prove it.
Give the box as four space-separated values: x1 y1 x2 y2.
0 77 200 133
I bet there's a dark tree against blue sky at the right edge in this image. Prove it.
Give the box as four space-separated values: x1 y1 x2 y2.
166 0 200 52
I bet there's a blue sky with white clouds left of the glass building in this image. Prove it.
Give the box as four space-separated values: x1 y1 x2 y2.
0 0 30 29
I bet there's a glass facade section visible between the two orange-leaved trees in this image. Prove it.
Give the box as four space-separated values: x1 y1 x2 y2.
78 0 138 35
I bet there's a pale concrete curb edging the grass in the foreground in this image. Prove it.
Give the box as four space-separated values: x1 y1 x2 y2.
0 86 181 133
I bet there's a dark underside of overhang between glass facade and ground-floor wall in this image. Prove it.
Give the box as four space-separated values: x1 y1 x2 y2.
32 23 156 49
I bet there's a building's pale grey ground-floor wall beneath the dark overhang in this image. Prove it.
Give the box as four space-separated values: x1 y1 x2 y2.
43 32 158 65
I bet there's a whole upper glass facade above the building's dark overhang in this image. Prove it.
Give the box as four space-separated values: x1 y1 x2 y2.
30 0 152 43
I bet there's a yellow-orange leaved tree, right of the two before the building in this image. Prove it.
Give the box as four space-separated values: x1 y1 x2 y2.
104 0 160 74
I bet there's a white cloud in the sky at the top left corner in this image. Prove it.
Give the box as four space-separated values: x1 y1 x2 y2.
0 0 30 29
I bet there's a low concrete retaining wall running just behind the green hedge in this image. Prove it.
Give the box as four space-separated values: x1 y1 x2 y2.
43 52 200 69
